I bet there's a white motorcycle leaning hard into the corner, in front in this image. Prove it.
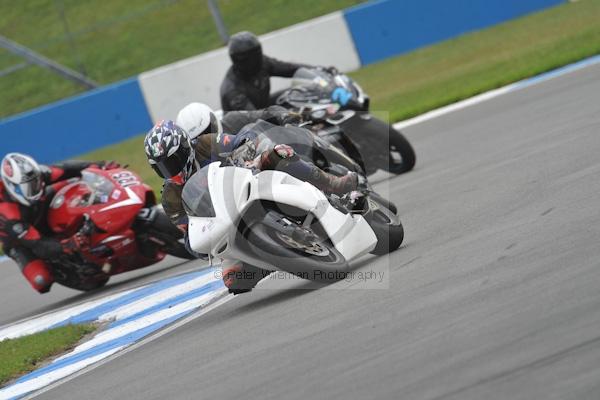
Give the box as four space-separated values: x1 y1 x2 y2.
182 162 404 281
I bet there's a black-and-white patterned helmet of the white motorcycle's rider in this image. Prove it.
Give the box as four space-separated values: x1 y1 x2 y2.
144 120 194 178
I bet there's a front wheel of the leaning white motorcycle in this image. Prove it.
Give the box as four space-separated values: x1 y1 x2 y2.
245 219 350 282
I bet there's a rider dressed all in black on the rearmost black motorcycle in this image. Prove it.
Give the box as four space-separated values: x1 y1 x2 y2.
221 31 337 111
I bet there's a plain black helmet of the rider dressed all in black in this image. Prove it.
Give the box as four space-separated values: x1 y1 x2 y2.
229 31 263 76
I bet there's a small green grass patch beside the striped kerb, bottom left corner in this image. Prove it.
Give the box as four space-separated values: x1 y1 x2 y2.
0 324 96 385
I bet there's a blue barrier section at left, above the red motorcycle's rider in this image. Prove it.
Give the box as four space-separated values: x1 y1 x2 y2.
0 78 152 162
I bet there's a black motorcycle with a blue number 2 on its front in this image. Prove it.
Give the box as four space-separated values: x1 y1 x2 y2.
276 68 416 174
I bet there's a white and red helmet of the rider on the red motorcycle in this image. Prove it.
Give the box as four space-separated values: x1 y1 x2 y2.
0 153 44 206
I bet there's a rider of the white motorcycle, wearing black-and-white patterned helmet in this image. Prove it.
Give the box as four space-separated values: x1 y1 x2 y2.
144 119 358 294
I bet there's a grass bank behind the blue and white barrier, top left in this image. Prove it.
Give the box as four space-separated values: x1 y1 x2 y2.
0 0 364 117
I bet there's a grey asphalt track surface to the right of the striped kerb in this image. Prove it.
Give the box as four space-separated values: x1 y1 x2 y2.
2 66 600 400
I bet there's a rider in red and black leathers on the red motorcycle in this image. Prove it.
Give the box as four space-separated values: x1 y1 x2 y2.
0 153 118 293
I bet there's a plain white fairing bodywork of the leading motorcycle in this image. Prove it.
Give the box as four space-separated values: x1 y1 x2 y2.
189 163 377 267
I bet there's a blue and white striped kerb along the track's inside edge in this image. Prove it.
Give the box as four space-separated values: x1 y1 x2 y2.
0 267 226 400
